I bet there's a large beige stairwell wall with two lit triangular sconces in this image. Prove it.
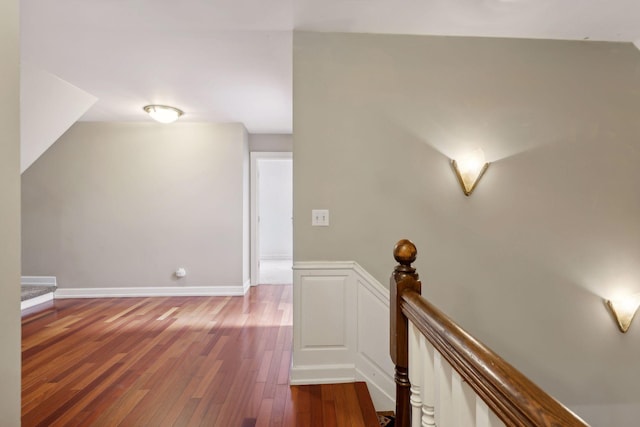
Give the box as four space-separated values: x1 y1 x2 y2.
294 32 640 422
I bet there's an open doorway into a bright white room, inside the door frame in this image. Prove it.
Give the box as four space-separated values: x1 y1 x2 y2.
251 152 293 286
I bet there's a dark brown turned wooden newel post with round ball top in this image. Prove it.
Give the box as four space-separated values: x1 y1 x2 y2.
389 239 421 427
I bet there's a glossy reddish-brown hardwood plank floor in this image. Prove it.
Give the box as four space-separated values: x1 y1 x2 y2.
22 286 377 427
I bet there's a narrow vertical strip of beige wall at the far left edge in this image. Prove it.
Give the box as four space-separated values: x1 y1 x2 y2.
0 0 20 427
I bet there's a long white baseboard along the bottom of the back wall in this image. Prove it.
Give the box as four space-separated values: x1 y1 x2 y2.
55 281 250 299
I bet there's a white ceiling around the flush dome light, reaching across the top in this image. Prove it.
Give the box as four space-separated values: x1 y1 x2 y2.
21 0 640 133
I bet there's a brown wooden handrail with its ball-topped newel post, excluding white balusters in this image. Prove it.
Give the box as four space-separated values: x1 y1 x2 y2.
390 240 587 427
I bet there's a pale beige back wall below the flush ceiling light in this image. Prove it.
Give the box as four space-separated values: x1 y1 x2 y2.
22 122 248 288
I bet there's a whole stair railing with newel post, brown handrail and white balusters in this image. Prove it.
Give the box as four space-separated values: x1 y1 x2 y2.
390 240 587 427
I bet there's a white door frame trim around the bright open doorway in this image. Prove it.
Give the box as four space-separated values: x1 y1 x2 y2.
250 151 293 286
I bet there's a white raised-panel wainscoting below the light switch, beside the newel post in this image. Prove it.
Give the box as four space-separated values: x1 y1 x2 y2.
291 261 395 411
